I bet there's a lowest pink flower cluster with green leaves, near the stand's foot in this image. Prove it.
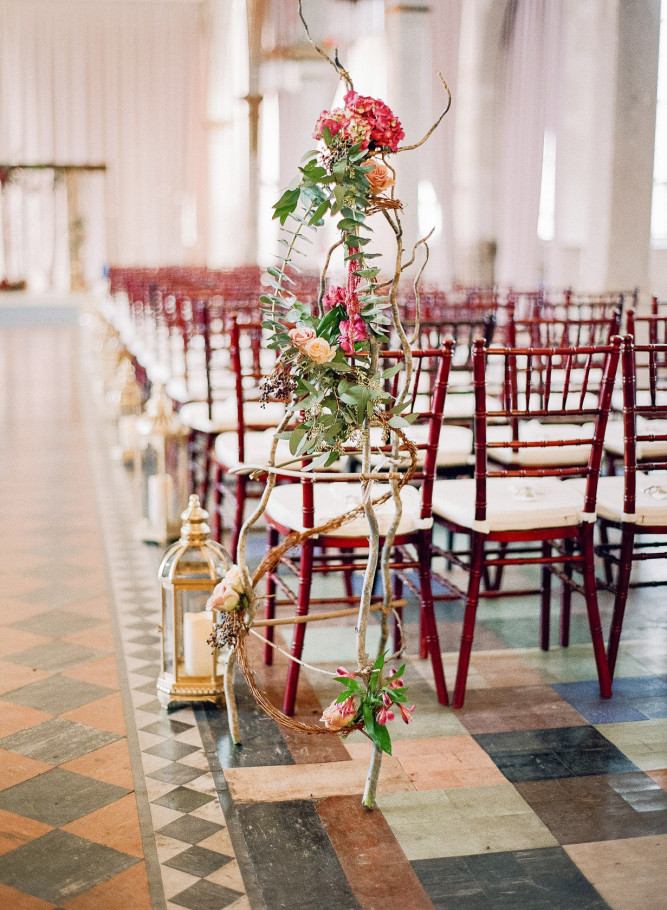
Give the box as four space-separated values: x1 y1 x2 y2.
320 652 415 755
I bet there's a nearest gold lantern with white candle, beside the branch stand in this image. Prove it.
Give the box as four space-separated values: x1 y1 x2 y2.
157 495 229 708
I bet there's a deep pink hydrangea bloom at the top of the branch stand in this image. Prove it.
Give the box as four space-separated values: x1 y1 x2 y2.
313 92 405 152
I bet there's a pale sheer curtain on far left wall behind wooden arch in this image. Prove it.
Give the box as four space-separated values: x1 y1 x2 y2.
0 0 207 284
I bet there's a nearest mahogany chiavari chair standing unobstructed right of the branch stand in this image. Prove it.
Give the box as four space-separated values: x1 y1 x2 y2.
433 336 621 707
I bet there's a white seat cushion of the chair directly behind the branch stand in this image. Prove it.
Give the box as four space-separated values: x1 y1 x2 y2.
266 481 432 539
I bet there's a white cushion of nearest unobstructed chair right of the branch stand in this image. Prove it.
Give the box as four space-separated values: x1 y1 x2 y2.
433 477 583 534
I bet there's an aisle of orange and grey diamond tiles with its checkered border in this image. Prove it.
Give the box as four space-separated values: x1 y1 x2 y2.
0 306 248 910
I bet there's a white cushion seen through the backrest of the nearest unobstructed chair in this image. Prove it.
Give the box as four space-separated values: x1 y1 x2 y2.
486 420 594 467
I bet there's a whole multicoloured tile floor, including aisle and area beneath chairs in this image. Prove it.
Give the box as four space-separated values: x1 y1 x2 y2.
0 308 667 910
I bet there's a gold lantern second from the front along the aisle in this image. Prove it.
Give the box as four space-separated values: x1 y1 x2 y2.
134 382 188 544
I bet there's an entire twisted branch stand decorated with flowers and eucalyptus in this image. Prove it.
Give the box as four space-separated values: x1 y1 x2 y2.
214 0 451 809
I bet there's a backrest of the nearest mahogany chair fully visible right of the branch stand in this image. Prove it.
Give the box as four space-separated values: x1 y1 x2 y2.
473 336 621 521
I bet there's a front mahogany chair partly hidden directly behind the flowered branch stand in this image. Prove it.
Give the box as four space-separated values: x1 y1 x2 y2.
264 339 453 715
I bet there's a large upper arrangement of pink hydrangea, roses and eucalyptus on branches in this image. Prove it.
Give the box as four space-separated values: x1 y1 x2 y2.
260 91 414 467
